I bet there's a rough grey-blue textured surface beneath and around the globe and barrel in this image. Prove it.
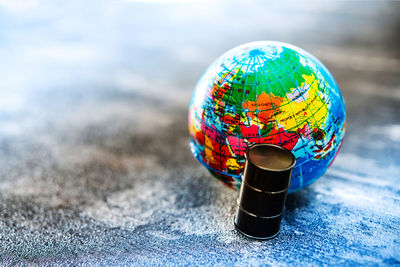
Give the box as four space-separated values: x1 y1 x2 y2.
0 0 400 266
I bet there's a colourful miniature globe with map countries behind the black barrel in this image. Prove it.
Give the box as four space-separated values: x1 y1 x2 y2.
188 41 346 192
